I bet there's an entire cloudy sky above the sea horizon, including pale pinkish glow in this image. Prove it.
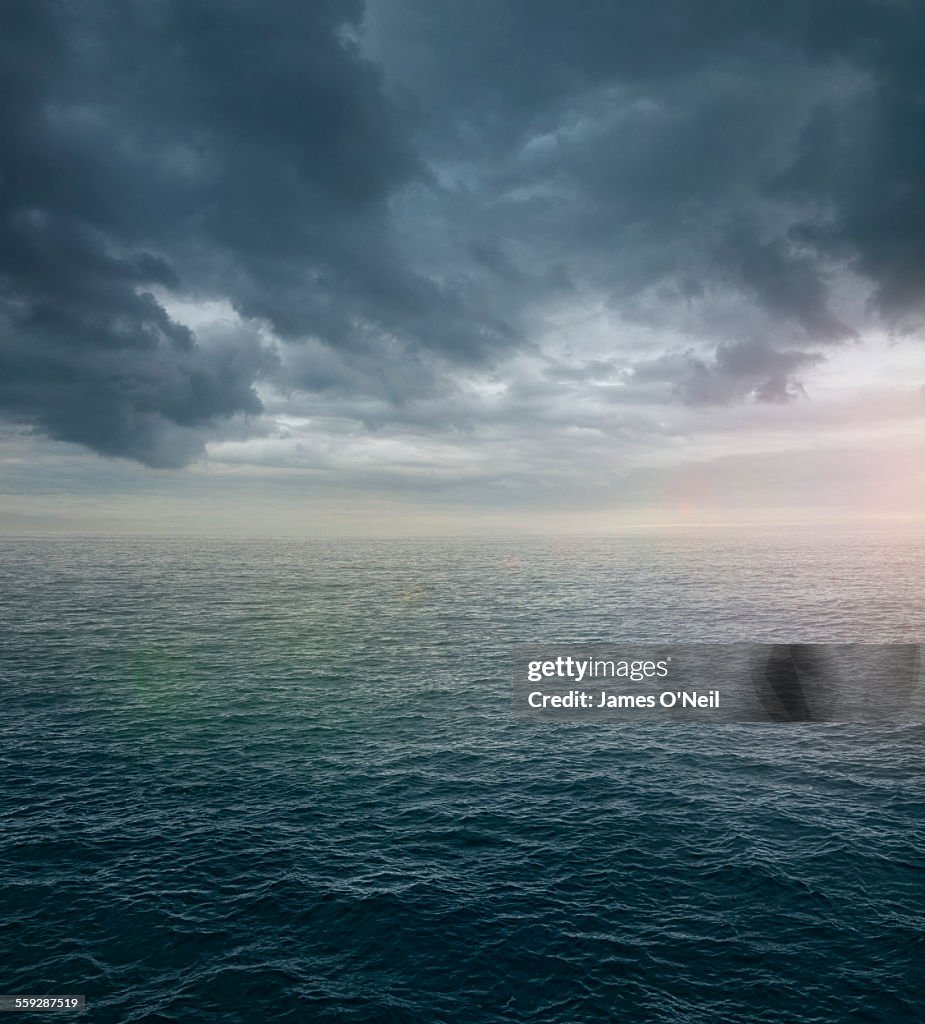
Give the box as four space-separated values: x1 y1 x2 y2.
0 0 925 536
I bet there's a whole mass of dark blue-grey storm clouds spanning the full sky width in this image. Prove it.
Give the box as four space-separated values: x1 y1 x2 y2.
0 0 925 465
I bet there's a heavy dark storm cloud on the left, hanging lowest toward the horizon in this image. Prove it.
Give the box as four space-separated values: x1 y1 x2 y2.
0 0 485 465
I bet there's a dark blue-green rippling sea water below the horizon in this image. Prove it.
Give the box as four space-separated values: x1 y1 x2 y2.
0 536 925 1024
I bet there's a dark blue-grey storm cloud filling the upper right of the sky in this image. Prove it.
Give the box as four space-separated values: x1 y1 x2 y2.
370 0 925 399
